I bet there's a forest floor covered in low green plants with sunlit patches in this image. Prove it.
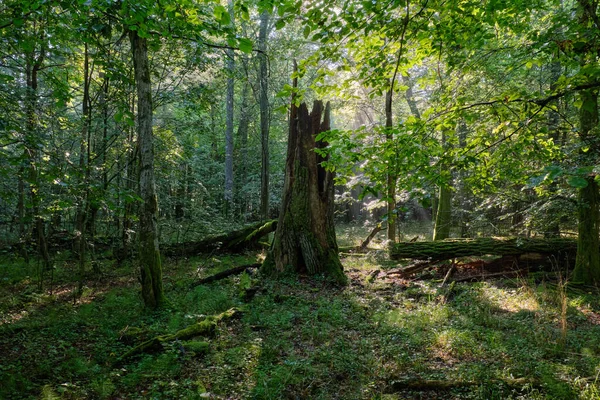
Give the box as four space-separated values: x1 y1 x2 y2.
0 225 600 399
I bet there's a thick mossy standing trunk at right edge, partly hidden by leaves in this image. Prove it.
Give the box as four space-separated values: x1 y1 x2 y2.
573 90 600 284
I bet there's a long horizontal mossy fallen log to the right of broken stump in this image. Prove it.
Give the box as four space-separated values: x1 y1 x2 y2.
390 238 577 261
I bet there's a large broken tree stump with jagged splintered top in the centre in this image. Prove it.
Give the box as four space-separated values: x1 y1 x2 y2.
262 98 347 283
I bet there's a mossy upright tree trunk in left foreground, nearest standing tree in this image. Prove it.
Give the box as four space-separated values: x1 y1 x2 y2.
129 31 166 308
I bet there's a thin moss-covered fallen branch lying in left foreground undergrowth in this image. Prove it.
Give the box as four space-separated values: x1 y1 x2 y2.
115 308 241 365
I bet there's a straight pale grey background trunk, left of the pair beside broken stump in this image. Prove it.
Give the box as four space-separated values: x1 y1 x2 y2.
224 0 235 215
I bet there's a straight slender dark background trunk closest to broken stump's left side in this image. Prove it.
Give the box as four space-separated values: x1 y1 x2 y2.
258 11 269 220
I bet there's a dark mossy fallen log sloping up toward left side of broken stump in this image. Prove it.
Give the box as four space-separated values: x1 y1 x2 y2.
162 220 277 257
